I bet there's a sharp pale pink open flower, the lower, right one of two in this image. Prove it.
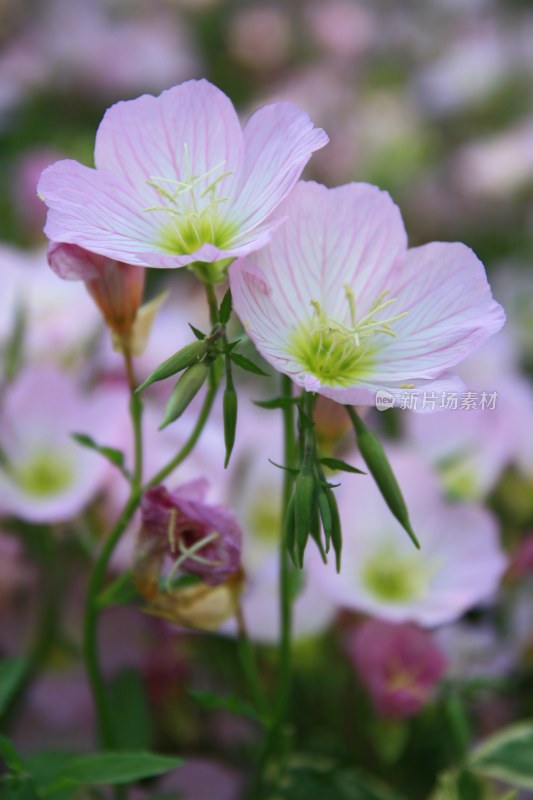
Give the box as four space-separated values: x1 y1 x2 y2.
230 182 504 405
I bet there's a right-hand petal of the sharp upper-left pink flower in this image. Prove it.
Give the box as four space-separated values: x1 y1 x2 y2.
232 102 328 230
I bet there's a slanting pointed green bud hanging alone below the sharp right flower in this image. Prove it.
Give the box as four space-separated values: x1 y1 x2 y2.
345 406 420 549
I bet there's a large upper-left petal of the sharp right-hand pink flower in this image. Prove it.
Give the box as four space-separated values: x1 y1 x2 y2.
230 181 407 350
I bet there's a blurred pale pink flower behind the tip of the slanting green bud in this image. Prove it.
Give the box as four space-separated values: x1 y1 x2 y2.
311 451 507 627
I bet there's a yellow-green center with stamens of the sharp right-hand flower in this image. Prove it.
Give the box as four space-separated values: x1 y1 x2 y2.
291 286 407 387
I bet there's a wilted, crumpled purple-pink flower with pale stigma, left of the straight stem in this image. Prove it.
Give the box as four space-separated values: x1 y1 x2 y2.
138 479 241 586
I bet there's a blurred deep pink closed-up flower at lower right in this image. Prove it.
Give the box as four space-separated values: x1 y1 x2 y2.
347 620 446 719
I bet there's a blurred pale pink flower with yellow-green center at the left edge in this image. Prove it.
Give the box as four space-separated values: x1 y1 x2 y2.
0 367 123 523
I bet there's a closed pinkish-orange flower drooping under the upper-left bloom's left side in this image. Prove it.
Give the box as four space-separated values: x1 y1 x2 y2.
48 242 146 337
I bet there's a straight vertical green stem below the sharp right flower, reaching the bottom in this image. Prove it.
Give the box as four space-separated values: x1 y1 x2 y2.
251 375 295 800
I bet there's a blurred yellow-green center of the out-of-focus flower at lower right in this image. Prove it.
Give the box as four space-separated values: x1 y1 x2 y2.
363 546 432 603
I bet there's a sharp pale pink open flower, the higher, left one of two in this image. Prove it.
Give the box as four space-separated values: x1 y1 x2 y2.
39 80 327 276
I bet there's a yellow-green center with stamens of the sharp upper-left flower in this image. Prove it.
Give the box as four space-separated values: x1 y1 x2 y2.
144 143 237 255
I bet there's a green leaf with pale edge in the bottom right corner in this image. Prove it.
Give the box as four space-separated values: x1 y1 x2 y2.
469 720 533 789
